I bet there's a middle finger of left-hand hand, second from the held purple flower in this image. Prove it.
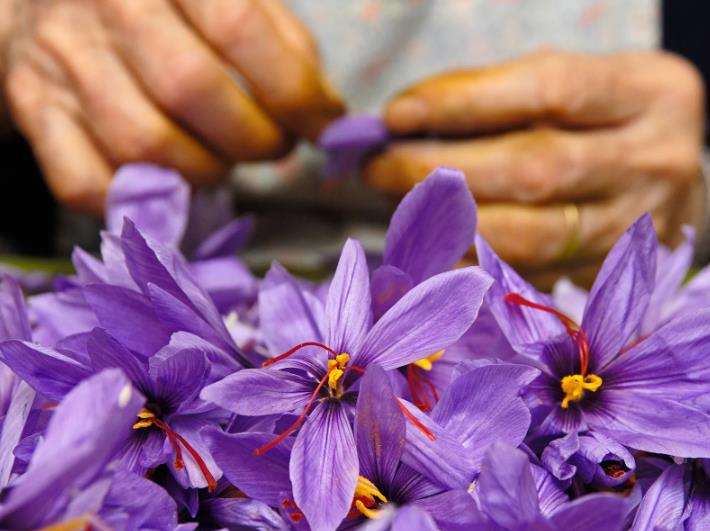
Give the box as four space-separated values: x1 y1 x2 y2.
100 0 288 161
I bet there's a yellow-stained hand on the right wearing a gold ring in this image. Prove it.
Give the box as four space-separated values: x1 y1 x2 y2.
365 48 704 278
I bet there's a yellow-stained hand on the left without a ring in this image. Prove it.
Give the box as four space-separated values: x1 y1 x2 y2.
0 0 343 213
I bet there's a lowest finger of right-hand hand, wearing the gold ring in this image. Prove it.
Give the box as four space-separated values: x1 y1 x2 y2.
478 182 675 269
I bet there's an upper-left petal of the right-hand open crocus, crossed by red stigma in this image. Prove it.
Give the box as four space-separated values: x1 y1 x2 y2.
476 236 565 350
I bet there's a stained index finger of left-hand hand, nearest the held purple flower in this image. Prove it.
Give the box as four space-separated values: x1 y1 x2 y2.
177 0 344 140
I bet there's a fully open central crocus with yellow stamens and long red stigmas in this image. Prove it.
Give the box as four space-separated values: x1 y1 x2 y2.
201 240 490 529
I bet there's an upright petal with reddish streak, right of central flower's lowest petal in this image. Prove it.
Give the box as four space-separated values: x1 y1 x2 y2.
355 366 406 485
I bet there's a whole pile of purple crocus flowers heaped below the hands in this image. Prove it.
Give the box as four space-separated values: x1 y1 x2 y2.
0 165 710 531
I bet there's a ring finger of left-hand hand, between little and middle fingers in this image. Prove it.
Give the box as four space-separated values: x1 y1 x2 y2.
37 3 226 184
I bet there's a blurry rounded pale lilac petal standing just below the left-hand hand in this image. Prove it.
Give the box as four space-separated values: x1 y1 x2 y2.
106 164 190 246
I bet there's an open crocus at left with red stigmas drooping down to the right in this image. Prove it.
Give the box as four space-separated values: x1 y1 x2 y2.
0 328 221 489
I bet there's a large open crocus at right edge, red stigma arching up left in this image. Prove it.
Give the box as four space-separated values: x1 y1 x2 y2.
477 215 710 457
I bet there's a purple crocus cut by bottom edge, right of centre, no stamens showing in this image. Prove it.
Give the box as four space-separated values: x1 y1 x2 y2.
475 443 633 531
